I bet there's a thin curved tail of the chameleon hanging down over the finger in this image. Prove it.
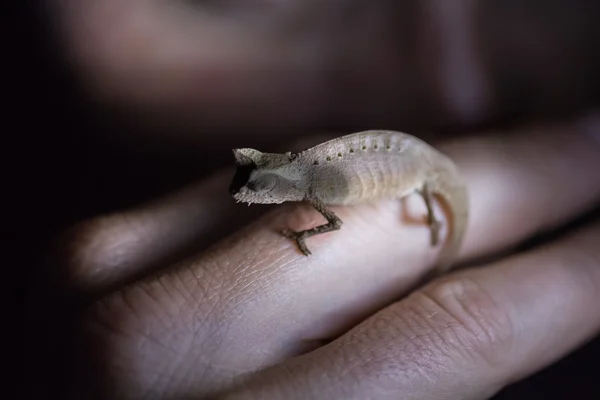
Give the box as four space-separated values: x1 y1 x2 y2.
430 174 469 275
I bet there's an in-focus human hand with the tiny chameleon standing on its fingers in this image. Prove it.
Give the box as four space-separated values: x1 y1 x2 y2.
37 119 600 399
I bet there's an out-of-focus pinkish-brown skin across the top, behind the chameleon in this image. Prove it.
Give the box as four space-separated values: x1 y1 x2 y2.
47 0 600 141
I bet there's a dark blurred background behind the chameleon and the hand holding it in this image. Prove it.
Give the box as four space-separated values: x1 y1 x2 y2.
12 0 600 399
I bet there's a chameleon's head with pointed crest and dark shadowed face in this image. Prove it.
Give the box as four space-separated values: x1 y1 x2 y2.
229 149 305 204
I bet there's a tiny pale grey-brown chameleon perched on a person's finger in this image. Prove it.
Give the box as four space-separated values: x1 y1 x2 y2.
229 130 469 273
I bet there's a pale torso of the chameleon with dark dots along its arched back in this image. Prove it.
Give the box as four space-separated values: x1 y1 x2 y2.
298 130 458 205
